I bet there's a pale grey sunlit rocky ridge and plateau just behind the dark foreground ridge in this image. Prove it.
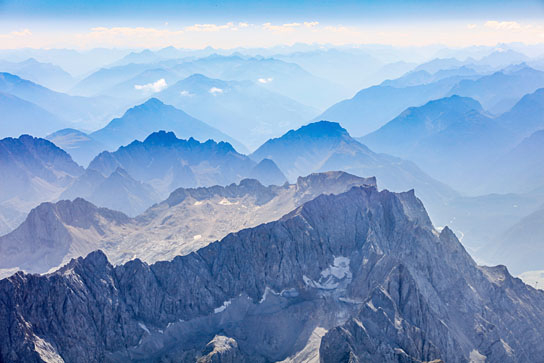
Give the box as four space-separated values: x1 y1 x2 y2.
0 170 376 276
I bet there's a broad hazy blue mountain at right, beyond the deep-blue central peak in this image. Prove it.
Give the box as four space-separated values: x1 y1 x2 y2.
360 96 509 188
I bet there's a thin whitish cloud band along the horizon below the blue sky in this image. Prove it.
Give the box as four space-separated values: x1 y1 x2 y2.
0 19 544 49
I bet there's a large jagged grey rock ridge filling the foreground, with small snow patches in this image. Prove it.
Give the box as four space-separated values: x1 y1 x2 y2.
0 186 544 362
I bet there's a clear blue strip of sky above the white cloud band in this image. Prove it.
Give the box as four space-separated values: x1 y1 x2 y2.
0 0 544 24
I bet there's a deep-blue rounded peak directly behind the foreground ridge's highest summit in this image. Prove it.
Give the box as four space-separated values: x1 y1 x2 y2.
250 121 456 216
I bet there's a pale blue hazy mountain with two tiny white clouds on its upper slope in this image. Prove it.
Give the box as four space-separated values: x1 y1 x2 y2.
156 74 317 149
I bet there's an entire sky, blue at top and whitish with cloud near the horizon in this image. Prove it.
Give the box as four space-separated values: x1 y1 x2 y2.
0 0 544 49
